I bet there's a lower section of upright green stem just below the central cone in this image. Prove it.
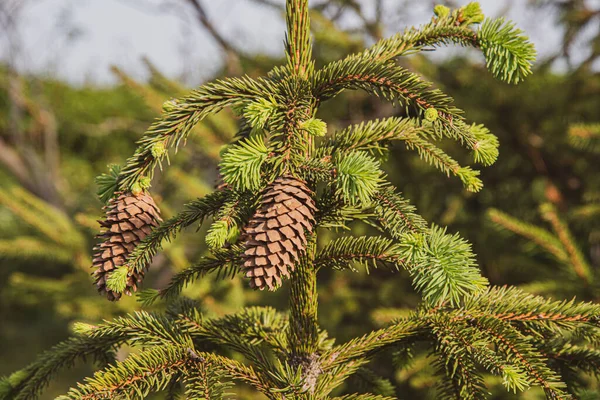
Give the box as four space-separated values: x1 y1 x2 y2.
288 235 318 354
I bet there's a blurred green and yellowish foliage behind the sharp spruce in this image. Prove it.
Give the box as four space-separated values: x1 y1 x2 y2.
0 0 600 399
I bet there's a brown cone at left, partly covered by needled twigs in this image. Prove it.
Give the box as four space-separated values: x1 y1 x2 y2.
92 192 162 301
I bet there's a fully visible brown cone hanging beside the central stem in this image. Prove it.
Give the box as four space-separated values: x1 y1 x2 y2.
243 176 317 290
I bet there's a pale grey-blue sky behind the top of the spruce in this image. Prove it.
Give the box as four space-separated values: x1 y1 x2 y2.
0 0 572 84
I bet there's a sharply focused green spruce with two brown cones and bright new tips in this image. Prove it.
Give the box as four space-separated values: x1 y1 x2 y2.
0 0 600 399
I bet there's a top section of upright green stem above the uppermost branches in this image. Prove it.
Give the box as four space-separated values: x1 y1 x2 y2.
286 0 312 78
